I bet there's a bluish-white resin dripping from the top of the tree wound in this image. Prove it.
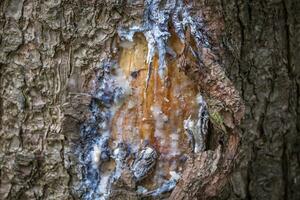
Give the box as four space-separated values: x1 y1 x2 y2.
118 0 209 79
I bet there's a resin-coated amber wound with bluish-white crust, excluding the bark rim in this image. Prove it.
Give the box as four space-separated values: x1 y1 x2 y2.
76 0 209 199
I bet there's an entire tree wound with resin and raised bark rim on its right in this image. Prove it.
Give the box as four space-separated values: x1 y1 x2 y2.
79 0 244 199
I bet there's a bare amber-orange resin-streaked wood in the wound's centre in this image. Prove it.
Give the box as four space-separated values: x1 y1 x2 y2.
112 34 198 187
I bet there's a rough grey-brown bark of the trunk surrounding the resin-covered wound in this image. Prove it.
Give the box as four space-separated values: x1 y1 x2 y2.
0 0 300 200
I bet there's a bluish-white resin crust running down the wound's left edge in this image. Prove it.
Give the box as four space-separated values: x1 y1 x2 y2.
78 60 131 200
